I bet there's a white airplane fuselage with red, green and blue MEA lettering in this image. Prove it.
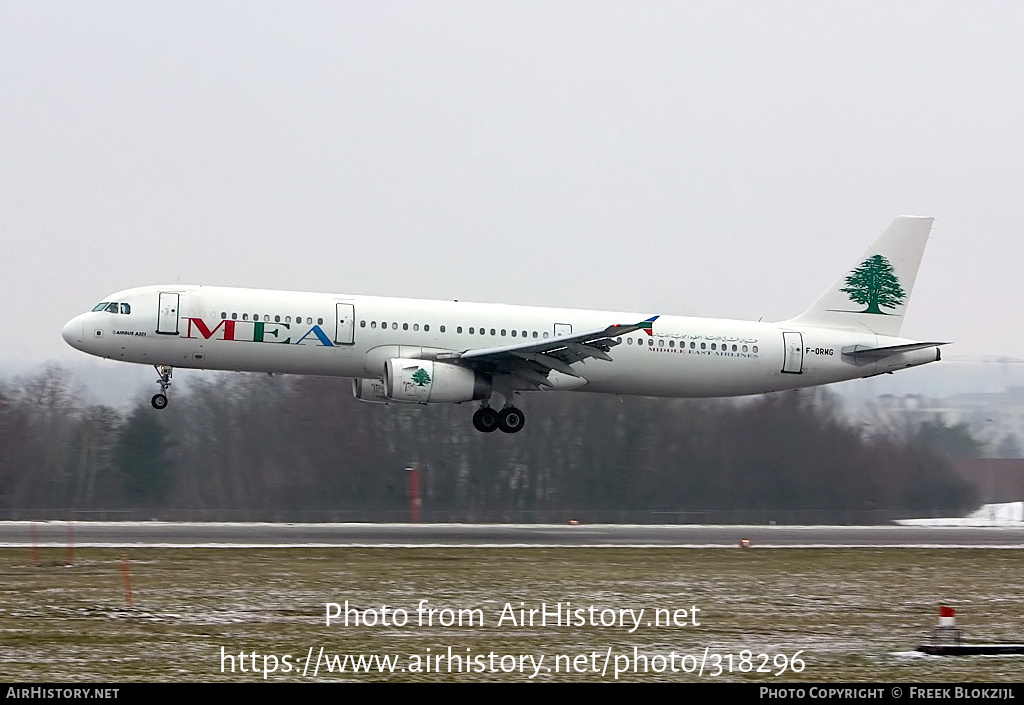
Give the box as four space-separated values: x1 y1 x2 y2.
62 285 938 397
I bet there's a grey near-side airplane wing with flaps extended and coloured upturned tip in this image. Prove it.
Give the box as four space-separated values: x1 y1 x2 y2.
438 316 658 388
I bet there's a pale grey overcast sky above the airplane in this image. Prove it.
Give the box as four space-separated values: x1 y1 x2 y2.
0 0 1024 375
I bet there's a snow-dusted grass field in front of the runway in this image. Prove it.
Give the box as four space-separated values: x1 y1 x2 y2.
0 548 1024 682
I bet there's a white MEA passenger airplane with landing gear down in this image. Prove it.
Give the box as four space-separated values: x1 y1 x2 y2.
62 216 947 433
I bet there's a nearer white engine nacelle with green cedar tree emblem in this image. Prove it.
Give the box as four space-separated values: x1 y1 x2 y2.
384 358 490 404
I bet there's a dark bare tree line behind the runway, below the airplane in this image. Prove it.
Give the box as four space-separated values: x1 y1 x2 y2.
0 365 978 521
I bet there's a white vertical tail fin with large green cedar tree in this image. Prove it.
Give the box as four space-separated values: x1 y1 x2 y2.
785 215 934 336
